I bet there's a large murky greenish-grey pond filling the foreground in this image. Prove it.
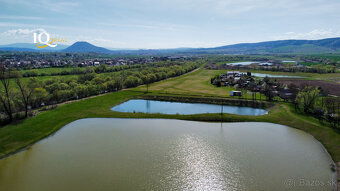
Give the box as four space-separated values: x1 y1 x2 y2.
0 118 335 191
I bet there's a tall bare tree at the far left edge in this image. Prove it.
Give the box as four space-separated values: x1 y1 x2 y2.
0 66 13 121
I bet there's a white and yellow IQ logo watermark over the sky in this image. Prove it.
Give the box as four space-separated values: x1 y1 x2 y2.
33 31 67 48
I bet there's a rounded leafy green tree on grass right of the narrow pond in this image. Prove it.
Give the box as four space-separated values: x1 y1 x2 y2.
296 86 320 113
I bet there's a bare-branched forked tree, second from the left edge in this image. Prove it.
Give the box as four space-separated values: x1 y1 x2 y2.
15 74 39 117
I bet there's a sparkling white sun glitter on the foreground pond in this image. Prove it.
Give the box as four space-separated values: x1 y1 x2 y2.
170 135 230 190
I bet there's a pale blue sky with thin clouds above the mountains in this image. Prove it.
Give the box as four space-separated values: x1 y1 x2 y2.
0 0 340 49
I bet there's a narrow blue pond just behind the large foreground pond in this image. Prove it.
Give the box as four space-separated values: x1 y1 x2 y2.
111 99 268 115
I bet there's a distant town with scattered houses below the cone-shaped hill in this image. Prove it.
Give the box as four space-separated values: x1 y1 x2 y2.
0 53 193 69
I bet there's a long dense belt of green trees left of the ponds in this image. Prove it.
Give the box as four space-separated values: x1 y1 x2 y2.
0 62 200 122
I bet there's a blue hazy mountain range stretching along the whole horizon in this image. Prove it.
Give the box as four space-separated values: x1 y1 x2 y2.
0 38 340 55
